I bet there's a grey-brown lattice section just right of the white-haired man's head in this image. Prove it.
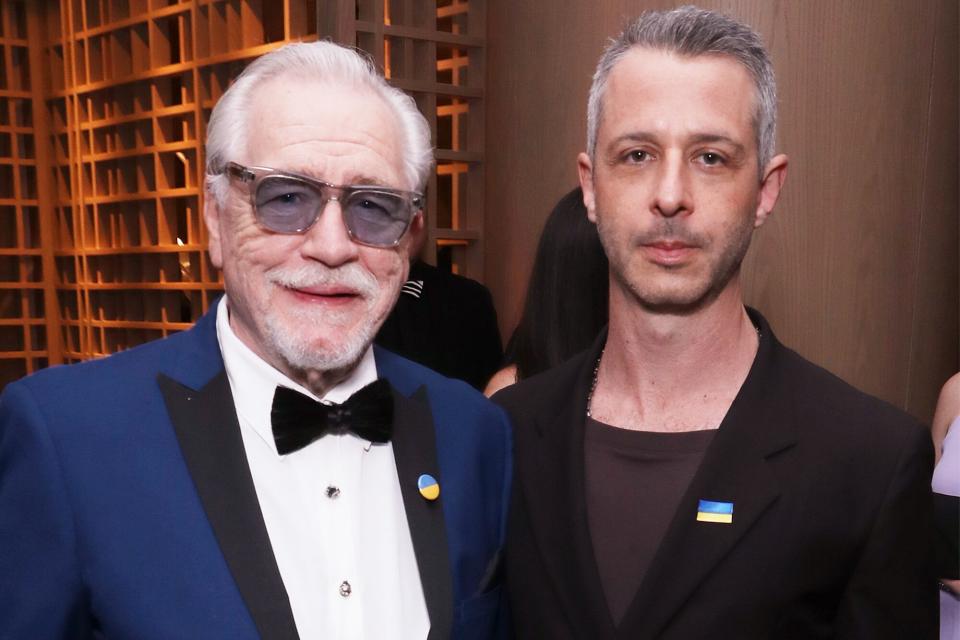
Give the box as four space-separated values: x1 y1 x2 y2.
319 0 486 280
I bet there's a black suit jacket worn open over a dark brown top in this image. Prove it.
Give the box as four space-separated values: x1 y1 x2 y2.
494 311 937 640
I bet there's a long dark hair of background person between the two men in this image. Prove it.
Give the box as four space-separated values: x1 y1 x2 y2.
506 187 609 380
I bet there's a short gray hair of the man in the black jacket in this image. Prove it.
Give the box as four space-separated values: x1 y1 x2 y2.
587 5 777 172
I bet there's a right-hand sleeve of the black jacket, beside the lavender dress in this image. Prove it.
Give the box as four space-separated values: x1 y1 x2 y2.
837 427 938 640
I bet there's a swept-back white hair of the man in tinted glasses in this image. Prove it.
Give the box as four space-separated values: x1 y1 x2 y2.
206 41 433 203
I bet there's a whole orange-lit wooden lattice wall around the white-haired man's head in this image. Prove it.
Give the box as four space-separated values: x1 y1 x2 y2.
0 0 484 384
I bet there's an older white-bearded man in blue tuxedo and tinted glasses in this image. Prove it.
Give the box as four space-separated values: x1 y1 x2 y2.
0 42 511 640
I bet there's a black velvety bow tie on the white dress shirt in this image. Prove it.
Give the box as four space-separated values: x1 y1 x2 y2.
270 378 393 455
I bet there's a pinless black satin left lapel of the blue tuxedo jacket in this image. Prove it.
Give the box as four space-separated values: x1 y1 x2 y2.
157 372 299 640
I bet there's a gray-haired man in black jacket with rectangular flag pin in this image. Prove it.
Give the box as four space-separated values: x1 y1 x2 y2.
496 7 936 640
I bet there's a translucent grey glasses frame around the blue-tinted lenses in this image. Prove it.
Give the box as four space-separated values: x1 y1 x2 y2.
220 162 424 249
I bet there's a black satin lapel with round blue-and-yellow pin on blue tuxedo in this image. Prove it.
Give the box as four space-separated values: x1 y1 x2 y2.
393 388 453 640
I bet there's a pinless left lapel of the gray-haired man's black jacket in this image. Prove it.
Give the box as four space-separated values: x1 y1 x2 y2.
517 335 614 639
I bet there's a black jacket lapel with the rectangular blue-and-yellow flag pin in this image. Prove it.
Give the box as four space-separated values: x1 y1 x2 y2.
618 315 796 638
